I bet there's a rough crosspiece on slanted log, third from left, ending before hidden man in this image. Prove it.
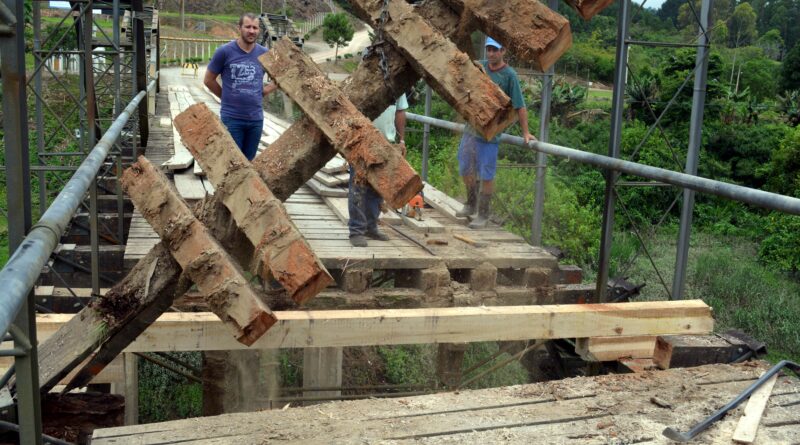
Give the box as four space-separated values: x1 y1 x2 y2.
259 38 422 208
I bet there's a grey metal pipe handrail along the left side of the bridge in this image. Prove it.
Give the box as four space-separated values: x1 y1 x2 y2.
0 80 156 332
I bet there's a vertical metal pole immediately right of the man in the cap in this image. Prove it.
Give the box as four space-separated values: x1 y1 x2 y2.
531 0 558 246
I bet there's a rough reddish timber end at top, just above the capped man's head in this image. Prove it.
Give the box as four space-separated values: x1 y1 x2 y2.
438 0 580 71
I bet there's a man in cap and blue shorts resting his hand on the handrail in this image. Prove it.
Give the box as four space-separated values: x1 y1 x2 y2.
456 37 536 229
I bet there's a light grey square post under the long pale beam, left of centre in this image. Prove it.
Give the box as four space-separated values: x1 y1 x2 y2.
303 348 343 405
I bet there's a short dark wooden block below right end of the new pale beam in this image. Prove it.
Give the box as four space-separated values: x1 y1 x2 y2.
653 335 749 369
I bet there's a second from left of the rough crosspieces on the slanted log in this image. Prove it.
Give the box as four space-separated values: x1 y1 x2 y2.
174 104 333 304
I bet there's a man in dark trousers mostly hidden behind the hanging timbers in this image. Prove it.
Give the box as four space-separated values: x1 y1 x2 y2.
347 94 408 247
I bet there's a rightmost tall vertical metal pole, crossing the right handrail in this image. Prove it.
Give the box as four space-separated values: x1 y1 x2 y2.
670 0 712 300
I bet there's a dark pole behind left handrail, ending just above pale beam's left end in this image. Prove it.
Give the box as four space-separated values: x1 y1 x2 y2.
81 0 100 295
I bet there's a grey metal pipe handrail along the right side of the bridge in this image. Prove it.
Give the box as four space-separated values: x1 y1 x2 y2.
407 113 800 215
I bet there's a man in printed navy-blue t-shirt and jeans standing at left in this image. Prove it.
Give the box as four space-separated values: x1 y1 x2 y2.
203 13 278 161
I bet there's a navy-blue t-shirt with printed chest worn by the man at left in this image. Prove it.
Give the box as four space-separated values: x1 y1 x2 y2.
208 40 268 121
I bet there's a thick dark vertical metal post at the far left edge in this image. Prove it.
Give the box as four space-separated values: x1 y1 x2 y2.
0 0 42 438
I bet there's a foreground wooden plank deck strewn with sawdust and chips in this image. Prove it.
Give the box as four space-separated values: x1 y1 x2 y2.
91 362 800 445
